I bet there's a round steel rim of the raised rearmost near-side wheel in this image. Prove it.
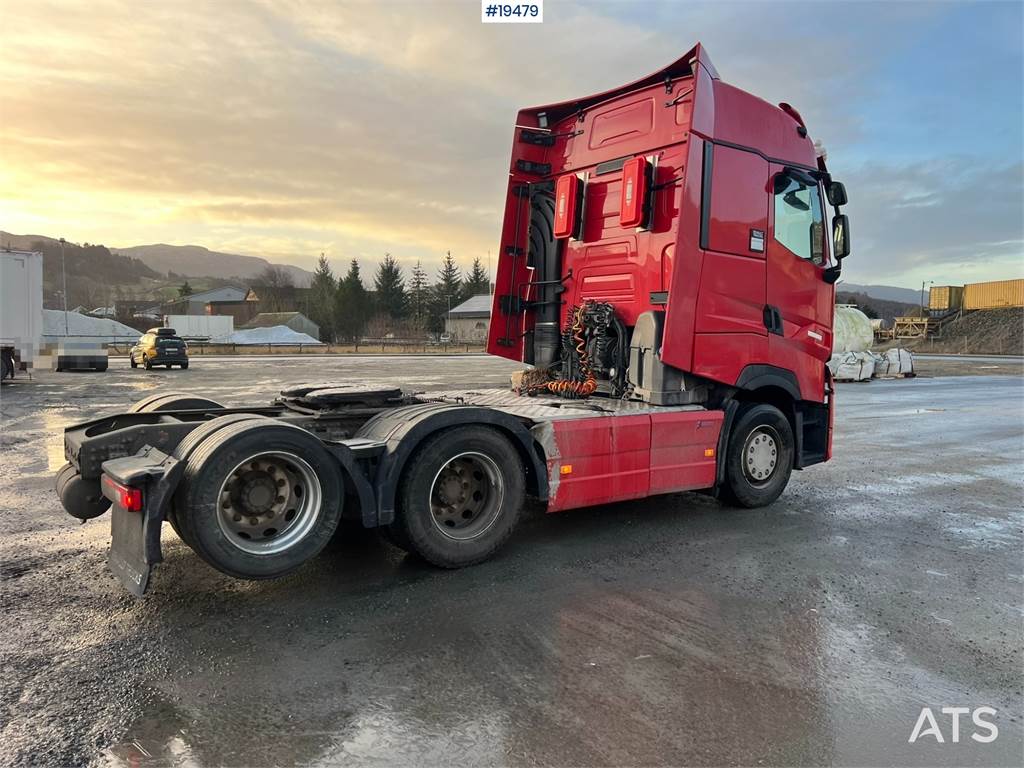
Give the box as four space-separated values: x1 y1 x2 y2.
217 451 324 555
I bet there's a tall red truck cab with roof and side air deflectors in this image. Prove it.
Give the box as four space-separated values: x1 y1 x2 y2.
487 44 849 468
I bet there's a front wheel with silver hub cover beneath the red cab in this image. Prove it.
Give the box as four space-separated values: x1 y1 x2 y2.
721 404 796 509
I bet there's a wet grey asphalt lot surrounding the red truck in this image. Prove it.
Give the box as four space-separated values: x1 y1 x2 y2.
0 356 1024 766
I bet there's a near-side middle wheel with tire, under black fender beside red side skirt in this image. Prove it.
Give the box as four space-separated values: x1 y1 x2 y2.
388 426 525 568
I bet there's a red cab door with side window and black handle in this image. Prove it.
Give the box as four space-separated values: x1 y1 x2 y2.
765 164 835 402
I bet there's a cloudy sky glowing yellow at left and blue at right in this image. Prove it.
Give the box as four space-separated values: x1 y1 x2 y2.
0 0 1024 287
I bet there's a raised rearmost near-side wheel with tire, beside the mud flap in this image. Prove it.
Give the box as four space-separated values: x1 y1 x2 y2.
173 417 344 580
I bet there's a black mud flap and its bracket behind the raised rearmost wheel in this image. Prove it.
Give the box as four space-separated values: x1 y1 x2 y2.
101 446 184 597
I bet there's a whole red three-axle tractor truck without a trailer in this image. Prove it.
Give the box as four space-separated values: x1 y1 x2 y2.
56 45 849 595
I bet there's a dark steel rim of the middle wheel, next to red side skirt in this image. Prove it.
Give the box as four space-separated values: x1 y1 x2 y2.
429 451 505 541
